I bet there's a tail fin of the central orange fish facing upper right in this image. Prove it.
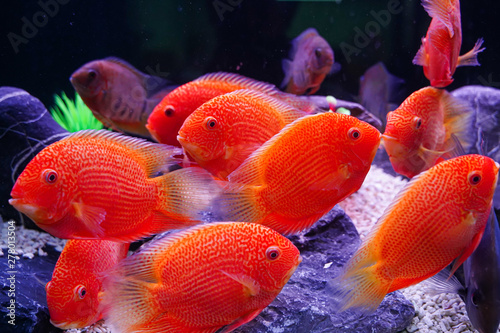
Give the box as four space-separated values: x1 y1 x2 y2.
214 183 267 223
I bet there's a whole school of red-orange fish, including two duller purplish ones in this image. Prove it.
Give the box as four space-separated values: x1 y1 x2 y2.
9 0 500 333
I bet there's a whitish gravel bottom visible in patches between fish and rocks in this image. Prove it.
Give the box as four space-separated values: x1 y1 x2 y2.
0 166 500 333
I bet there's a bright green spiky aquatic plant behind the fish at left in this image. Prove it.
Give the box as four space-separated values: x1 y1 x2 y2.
50 91 103 132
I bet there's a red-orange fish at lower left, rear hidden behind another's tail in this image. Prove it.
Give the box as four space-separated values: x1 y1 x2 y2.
45 239 129 330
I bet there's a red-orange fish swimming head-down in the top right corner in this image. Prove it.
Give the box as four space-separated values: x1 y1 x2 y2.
413 0 484 88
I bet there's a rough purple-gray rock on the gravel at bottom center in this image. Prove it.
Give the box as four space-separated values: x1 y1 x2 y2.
235 207 415 333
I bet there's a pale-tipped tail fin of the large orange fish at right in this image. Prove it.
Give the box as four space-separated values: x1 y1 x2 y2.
328 247 391 315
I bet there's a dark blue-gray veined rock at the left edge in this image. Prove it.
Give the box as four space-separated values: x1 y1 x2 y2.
0 87 68 228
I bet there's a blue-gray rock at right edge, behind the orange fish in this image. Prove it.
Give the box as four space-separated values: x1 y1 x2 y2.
452 86 500 209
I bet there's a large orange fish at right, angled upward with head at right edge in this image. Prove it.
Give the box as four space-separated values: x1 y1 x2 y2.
333 155 500 313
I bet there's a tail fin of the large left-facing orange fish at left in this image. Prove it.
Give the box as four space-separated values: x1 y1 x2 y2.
157 167 221 224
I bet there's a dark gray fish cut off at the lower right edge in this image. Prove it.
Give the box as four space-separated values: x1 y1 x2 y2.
430 208 500 333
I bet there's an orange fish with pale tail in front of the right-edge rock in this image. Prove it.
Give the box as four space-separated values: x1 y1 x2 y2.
383 87 473 178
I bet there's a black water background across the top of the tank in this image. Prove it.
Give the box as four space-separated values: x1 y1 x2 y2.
0 0 500 106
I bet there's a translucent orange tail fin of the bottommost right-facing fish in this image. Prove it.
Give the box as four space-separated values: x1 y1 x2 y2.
100 256 159 332
